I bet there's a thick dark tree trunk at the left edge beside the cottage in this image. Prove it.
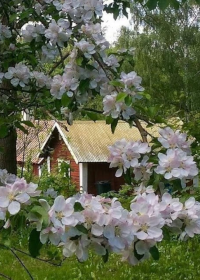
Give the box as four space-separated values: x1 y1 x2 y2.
0 129 17 174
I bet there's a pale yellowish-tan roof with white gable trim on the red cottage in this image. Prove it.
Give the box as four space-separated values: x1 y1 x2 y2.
38 121 158 163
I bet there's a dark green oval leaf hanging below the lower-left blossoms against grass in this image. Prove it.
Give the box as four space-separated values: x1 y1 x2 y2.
28 229 43 258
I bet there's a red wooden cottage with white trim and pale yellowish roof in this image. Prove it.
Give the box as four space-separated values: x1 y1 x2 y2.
17 121 155 194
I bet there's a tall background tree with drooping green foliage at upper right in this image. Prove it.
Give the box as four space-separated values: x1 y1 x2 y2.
116 3 200 127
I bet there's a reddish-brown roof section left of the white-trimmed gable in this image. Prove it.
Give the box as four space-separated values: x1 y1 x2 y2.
17 120 55 163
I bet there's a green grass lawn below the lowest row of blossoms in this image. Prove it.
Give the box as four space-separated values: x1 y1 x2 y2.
0 237 200 280
